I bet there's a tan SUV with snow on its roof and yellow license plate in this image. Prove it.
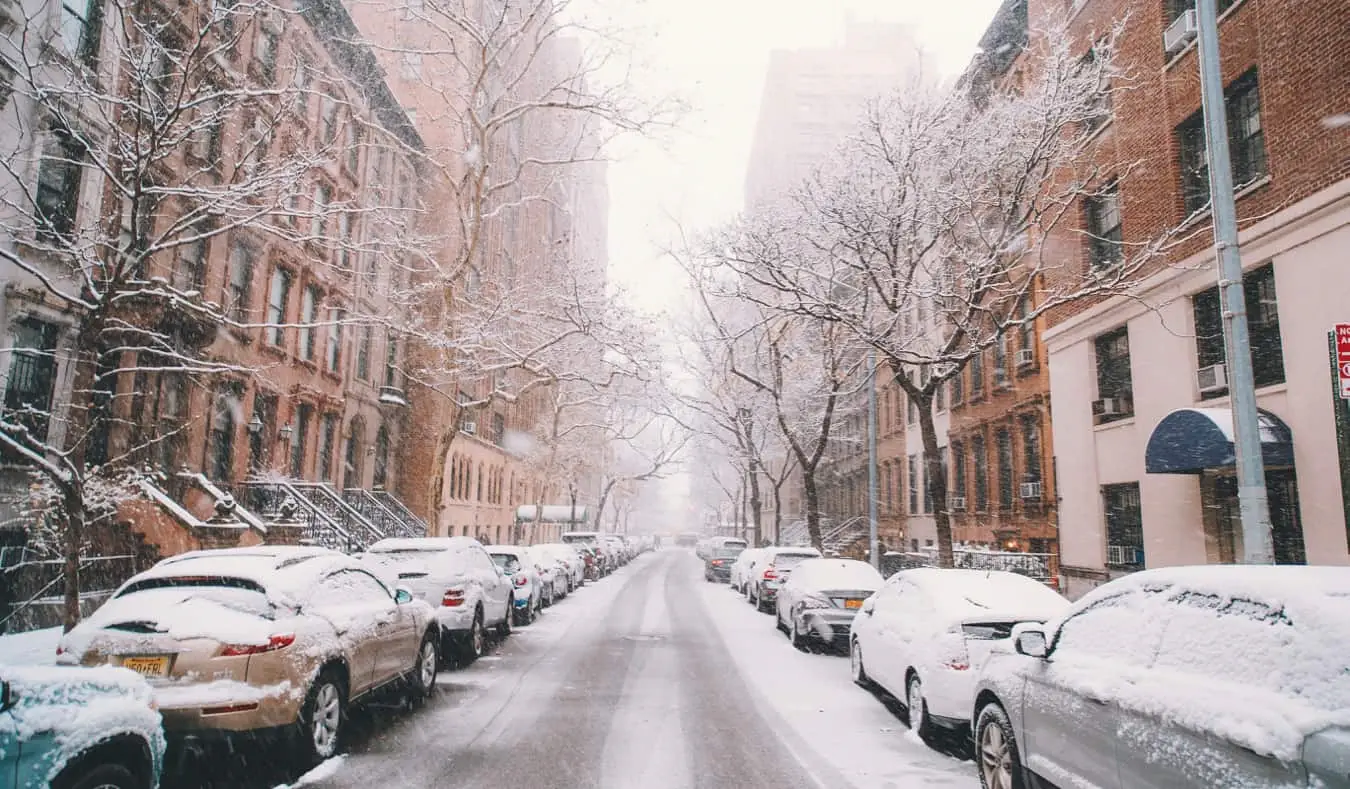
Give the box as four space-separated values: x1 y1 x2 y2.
57 546 439 761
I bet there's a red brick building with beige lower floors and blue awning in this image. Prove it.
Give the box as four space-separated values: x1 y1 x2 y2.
1029 0 1350 594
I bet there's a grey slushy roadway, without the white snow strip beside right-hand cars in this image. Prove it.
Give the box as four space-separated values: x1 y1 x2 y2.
167 550 846 789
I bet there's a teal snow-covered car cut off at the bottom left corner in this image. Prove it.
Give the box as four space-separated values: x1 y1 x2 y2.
0 666 165 789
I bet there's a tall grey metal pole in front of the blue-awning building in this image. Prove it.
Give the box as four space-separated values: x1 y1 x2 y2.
1196 0 1274 565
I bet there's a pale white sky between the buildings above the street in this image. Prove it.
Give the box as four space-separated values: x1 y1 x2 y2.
609 0 999 311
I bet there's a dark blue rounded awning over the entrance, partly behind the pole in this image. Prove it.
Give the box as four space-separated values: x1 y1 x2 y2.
1143 408 1293 474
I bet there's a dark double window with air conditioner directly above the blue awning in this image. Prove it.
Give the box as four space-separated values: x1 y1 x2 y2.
1191 263 1284 399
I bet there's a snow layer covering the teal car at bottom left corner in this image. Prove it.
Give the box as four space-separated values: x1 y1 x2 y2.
0 666 165 781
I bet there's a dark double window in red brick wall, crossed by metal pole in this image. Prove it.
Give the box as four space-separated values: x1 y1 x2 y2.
1176 69 1266 213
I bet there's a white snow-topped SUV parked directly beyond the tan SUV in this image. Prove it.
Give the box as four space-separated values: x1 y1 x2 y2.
360 536 516 665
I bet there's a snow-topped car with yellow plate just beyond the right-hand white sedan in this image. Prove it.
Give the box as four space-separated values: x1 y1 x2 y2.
774 559 886 650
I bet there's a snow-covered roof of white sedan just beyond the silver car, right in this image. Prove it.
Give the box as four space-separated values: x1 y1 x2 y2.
892 567 1069 621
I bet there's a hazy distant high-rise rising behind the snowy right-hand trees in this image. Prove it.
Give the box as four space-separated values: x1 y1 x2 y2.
745 19 919 208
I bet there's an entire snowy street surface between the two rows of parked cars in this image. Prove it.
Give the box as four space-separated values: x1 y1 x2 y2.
137 550 977 789
